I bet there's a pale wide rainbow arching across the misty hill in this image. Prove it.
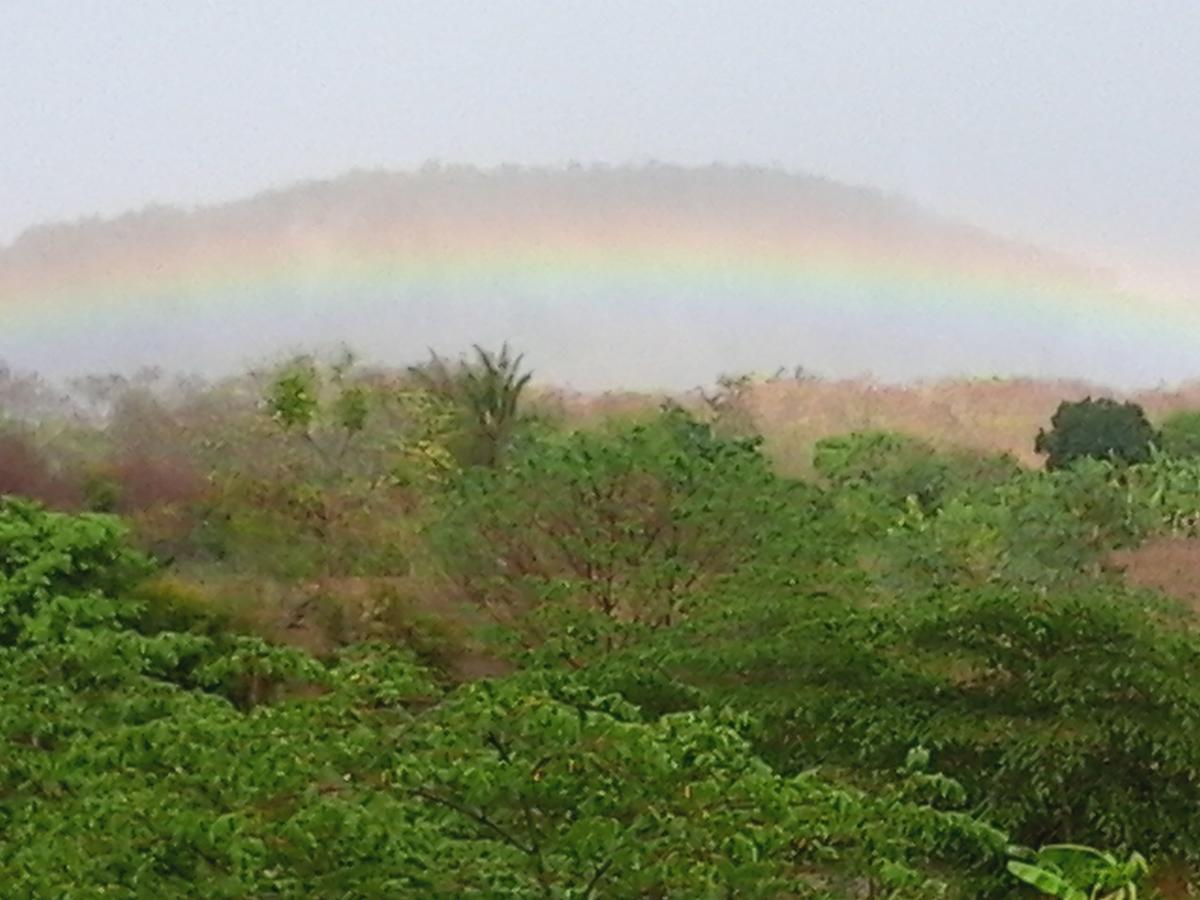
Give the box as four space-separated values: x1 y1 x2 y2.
0 169 1200 388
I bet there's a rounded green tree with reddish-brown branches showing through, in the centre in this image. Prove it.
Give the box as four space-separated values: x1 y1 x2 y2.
434 409 799 649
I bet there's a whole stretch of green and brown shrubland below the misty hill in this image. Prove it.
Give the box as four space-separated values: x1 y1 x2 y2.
0 348 1200 898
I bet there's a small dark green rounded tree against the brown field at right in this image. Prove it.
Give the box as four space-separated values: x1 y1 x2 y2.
1033 397 1156 469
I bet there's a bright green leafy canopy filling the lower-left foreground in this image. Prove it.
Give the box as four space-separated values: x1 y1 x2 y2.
0 518 1004 898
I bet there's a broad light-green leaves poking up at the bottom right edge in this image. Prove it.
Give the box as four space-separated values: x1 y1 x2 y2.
1008 844 1150 900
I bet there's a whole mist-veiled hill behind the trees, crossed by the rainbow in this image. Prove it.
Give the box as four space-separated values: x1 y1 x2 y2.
0 166 1200 389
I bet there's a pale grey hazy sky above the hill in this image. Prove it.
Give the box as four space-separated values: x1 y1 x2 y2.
0 0 1200 289
